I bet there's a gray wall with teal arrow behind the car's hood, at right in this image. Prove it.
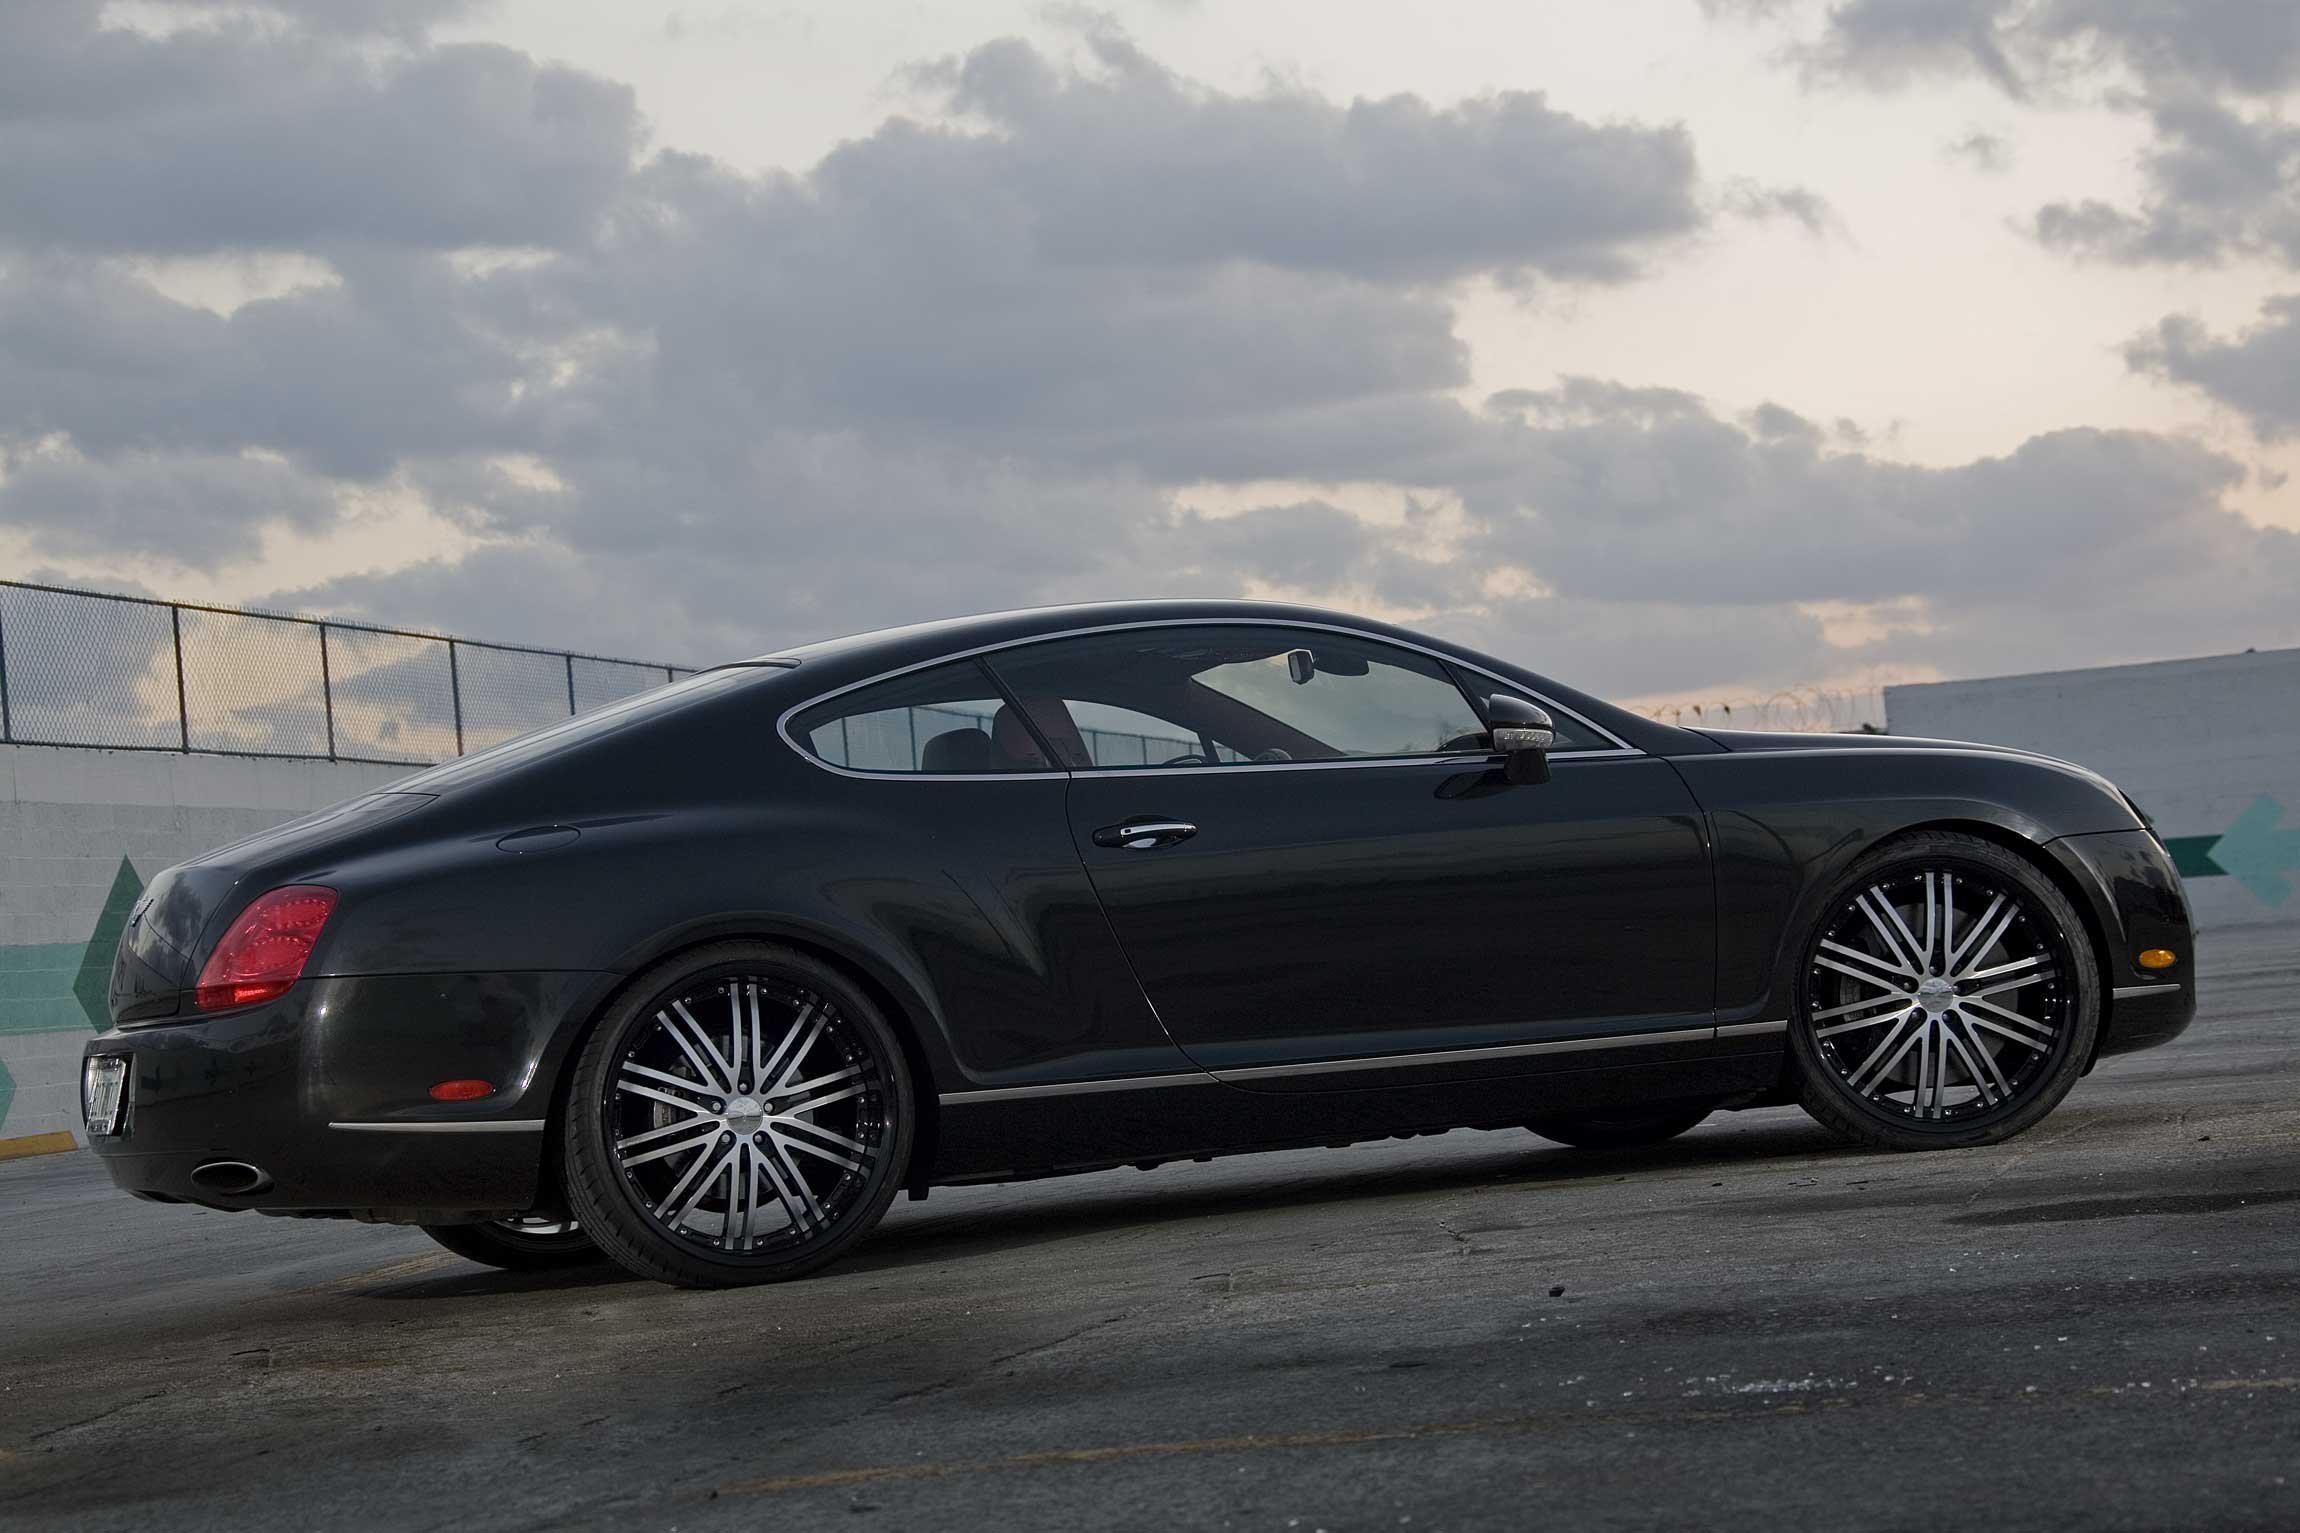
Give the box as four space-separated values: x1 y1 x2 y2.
1884 650 2300 929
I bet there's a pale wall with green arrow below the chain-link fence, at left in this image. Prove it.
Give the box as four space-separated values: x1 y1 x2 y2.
0 745 412 1142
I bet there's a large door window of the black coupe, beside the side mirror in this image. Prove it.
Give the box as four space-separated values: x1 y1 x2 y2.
991 625 1486 768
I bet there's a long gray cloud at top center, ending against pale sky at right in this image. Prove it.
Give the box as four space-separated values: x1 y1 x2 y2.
910 30 1700 280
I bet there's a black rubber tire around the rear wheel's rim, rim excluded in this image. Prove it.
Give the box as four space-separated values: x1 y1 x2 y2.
564 942 918 1287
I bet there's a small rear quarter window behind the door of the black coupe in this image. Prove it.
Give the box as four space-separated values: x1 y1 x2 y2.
791 660 1049 775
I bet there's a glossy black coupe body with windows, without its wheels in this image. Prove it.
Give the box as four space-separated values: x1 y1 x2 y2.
87 602 2194 1287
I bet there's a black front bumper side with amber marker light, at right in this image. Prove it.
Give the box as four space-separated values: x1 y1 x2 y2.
2052 830 2197 1060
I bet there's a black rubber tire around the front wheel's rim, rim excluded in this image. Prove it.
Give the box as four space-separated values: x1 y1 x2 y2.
1789 832 2102 1149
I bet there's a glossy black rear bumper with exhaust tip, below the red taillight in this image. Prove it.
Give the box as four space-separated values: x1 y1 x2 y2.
85 975 612 1223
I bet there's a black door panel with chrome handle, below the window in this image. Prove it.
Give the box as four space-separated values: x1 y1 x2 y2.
1070 754 1716 1089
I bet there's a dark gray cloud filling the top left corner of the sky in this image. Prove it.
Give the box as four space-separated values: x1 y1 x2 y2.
0 0 639 253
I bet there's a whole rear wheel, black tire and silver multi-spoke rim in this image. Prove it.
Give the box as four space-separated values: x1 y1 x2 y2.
564 942 918 1287
